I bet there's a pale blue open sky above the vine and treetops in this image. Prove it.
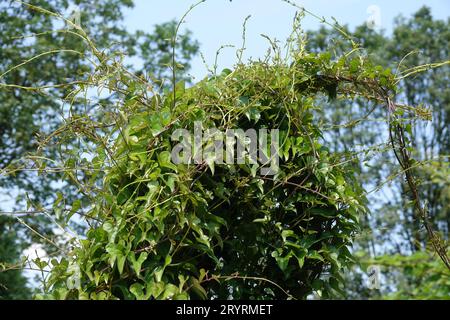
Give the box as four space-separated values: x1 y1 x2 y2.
125 0 450 80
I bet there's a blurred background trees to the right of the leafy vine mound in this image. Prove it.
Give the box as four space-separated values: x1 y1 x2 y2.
309 7 450 297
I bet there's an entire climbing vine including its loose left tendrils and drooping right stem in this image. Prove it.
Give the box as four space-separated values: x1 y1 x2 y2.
1 0 450 300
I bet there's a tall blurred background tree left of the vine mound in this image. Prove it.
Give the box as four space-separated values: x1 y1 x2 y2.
0 0 198 296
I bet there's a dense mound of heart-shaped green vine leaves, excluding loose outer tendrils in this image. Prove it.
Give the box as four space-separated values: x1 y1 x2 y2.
37 35 404 299
